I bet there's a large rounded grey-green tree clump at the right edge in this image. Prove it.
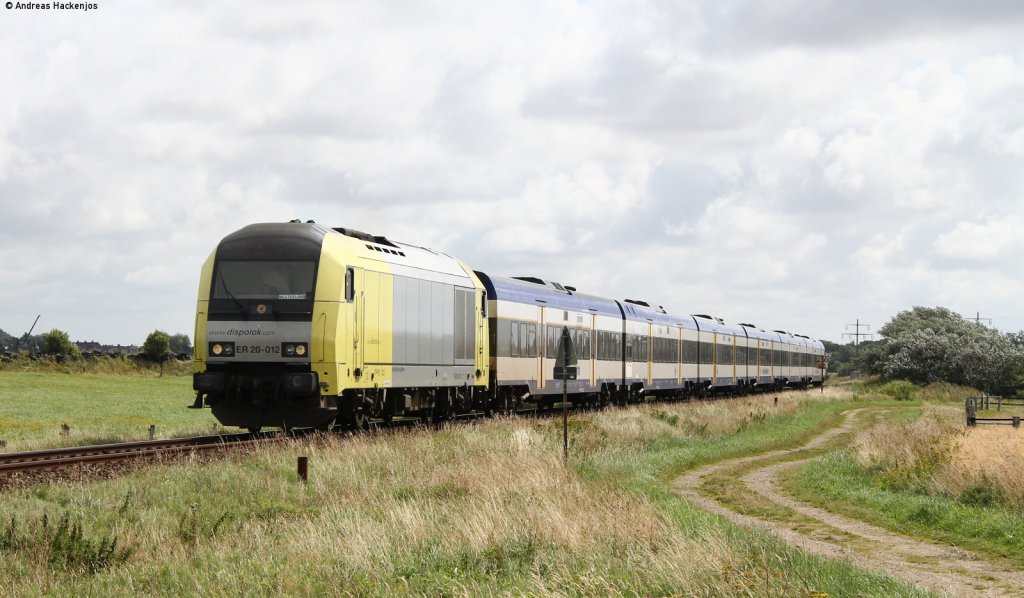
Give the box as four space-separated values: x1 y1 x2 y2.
878 307 1024 392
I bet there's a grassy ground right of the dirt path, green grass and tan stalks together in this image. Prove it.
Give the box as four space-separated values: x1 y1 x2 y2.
783 402 1024 567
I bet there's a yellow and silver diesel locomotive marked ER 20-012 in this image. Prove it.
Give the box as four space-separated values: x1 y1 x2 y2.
194 221 488 430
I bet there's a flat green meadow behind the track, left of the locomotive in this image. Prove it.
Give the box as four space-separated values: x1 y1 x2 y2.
0 372 220 451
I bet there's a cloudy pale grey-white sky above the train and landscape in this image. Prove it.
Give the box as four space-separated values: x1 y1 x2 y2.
0 0 1024 344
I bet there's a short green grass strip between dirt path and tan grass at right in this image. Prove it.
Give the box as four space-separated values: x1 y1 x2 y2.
781 451 1024 566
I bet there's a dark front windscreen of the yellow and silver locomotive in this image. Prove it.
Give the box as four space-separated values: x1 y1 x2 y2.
213 261 316 300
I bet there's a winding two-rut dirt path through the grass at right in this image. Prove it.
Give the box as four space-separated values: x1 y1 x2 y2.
673 410 1024 596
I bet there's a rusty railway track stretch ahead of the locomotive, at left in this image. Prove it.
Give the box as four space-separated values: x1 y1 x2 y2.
0 432 279 476
